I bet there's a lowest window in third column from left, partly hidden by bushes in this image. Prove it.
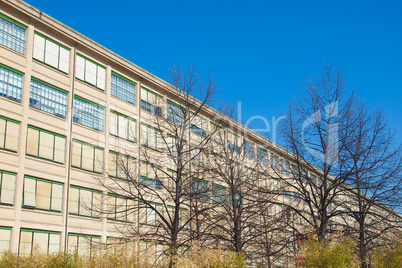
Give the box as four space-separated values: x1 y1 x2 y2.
68 233 101 256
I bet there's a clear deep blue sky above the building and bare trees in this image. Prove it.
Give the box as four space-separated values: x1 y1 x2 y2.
27 0 402 142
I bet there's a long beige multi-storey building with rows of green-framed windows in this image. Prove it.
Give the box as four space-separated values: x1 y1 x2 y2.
0 0 400 266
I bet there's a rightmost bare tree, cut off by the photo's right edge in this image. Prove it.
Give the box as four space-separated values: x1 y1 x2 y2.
343 102 402 267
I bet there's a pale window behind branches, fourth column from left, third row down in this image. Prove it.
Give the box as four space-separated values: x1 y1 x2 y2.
108 151 136 180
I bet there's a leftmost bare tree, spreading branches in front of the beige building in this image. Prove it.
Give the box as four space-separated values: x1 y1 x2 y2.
102 65 226 266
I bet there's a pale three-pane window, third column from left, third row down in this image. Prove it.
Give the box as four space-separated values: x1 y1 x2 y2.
71 140 103 173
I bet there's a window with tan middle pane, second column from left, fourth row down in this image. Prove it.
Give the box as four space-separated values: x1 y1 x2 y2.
22 176 63 212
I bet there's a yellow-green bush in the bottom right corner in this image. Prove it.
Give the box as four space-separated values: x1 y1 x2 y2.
374 233 402 268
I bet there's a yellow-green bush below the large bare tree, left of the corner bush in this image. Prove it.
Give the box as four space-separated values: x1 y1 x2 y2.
301 234 360 268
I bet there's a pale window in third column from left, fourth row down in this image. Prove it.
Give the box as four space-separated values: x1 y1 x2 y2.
68 186 102 218
